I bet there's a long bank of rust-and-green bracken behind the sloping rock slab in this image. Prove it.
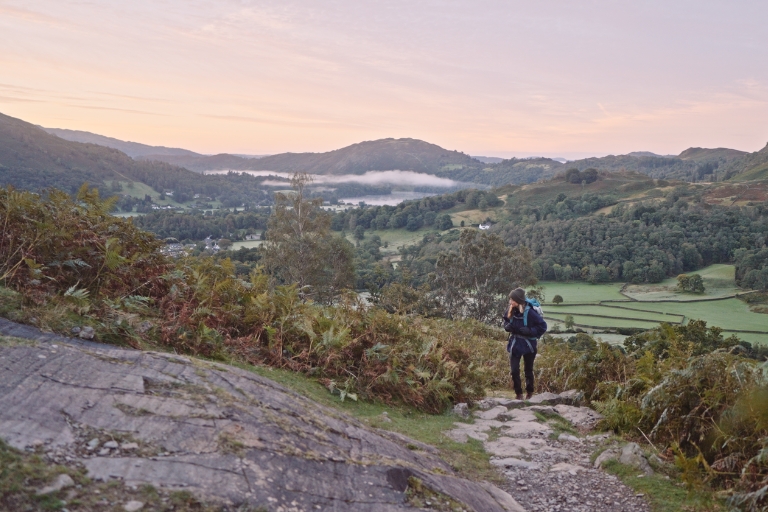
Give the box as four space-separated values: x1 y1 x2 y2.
0 187 508 413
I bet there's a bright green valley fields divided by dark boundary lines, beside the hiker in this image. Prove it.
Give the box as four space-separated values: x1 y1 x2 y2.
541 265 768 344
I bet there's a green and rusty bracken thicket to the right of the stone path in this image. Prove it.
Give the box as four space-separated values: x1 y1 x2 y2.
536 322 768 502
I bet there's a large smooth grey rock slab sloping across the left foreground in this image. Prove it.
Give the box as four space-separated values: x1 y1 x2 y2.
0 319 522 511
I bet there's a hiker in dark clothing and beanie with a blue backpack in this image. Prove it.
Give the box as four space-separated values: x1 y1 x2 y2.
502 288 547 400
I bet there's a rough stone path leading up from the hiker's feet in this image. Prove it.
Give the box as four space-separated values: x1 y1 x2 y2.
447 392 652 512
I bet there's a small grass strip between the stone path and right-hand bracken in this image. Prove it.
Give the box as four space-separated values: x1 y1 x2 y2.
604 460 726 512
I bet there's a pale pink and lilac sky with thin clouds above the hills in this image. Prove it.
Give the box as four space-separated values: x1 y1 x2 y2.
0 0 768 158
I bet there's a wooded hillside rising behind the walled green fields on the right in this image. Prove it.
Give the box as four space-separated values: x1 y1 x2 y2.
324 173 768 289
